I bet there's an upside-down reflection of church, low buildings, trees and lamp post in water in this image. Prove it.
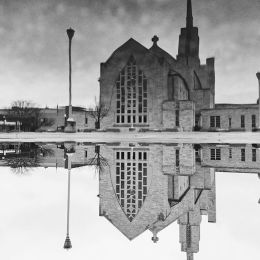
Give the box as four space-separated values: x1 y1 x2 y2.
0 142 260 259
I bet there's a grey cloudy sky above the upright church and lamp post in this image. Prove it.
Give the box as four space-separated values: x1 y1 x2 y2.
0 0 260 107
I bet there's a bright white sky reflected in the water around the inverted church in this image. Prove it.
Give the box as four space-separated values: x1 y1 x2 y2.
0 167 260 260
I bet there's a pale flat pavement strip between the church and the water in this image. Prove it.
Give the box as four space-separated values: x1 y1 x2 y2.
0 132 260 144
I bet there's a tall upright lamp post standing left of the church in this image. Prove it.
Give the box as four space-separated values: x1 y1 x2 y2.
65 28 76 133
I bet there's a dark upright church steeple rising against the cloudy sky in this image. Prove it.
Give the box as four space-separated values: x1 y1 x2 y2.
177 0 200 66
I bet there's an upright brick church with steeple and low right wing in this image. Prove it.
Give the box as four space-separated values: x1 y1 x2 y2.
100 0 259 131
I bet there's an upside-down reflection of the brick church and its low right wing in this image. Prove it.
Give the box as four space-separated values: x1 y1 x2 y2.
99 143 260 259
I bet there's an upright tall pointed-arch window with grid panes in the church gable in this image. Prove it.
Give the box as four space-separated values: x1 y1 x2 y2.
116 56 147 125
